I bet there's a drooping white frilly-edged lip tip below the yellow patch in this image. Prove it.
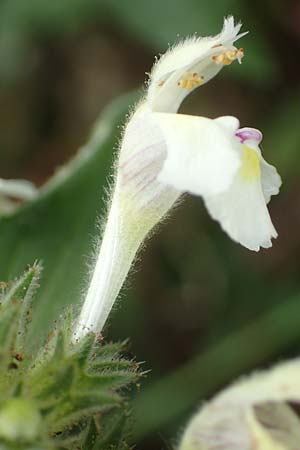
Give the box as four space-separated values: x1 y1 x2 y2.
204 174 277 251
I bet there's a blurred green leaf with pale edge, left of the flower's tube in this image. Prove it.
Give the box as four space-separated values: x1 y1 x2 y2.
0 91 138 346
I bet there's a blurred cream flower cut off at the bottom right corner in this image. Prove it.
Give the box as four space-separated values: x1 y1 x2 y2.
178 358 300 450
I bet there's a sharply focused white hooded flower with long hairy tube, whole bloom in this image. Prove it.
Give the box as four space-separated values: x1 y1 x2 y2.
75 17 281 339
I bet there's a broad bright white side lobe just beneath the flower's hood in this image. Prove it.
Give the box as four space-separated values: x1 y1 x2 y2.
153 113 240 195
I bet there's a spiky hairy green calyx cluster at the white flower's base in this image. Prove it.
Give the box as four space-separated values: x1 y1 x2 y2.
0 264 139 450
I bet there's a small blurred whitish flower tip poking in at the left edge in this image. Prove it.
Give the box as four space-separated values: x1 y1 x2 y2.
0 178 37 216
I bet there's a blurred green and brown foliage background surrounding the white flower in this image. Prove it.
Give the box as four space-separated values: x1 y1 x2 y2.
0 0 300 450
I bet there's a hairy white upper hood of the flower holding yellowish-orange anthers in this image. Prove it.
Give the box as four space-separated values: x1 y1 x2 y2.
147 17 247 113
